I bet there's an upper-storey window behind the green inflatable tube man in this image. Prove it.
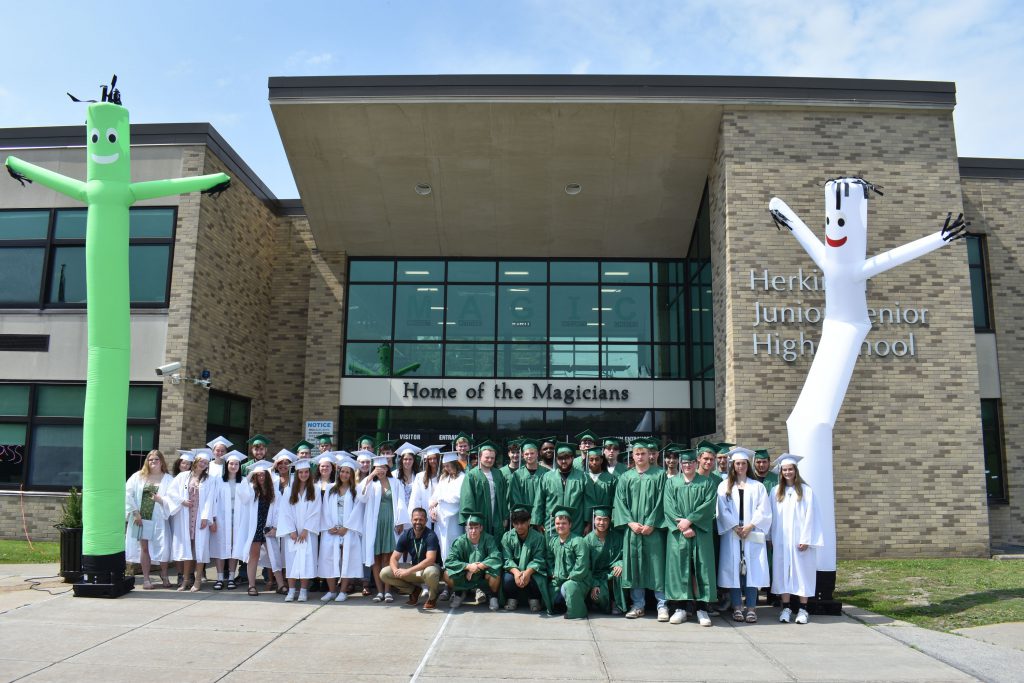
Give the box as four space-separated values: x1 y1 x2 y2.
0 207 177 308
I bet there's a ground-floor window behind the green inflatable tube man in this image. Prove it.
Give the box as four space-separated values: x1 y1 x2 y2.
0 383 161 490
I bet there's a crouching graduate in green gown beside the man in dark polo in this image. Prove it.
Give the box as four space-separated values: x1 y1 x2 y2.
443 512 504 610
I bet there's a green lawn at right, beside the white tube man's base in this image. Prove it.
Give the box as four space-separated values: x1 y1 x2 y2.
836 559 1024 631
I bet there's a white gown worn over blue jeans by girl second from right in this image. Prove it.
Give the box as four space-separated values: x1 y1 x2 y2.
718 478 771 588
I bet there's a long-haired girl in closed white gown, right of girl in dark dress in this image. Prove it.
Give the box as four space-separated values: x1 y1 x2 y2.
278 459 321 602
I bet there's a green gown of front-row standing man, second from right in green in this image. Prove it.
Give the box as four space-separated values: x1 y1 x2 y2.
611 466 668 591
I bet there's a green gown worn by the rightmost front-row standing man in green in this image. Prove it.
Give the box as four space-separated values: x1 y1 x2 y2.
662 474 718 602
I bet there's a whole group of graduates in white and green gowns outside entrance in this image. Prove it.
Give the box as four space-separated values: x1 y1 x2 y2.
126 430 822 626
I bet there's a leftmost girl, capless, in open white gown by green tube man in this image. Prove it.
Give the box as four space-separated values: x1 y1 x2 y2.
125 451 174 590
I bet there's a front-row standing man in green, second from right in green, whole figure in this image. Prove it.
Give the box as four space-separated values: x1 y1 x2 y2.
611 439 669 622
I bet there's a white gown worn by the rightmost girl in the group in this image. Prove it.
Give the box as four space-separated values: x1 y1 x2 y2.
769 483 824 597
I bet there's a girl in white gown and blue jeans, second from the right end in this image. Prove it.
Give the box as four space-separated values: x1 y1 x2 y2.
718 446 771 624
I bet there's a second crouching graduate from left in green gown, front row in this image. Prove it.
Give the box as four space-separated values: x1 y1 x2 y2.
501 508 551 612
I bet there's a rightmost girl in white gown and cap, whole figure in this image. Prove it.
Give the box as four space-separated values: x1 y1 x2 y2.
769 453 824 624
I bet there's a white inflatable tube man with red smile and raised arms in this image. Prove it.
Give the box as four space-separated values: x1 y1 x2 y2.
768 178 966 571
